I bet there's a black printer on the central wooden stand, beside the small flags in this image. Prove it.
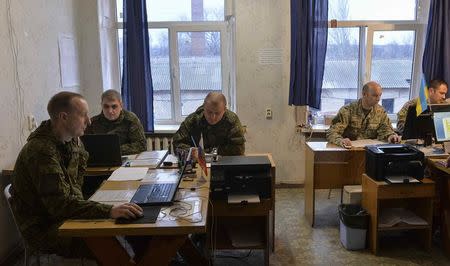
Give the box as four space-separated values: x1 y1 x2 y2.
210 156 272 199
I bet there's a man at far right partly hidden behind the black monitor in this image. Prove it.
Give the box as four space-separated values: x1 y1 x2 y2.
397 79 448 135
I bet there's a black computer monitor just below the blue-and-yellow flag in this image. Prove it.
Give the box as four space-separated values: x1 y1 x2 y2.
402 105 436 140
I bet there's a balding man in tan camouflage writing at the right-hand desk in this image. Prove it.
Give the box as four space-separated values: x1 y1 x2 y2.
327 81 400 148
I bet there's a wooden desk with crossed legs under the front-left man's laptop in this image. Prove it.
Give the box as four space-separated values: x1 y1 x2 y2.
59 169 209 265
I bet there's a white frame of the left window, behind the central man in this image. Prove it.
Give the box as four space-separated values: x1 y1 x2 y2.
116 0 236 126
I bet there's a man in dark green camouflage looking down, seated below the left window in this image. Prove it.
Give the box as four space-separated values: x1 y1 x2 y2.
173 92 245 155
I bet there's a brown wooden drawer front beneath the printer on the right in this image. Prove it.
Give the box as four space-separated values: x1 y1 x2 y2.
378 184 434 199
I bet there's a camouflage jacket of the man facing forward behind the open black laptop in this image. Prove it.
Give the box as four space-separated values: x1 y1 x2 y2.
86 110 147 155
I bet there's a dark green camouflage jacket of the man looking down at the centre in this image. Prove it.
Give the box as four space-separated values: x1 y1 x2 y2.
173 106 245 155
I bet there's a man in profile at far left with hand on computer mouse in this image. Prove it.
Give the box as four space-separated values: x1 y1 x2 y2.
10 92 142 257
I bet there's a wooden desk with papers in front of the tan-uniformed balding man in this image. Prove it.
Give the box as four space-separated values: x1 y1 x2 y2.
305 141 366 226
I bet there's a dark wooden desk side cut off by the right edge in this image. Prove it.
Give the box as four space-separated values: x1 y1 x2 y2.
427 158 450 257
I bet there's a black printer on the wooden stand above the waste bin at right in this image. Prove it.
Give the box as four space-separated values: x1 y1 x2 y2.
365 144 425 181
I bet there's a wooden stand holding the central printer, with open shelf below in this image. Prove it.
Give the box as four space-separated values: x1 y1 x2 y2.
208 154 275 265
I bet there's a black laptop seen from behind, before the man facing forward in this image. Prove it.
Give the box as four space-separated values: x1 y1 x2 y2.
81 134 122 166
